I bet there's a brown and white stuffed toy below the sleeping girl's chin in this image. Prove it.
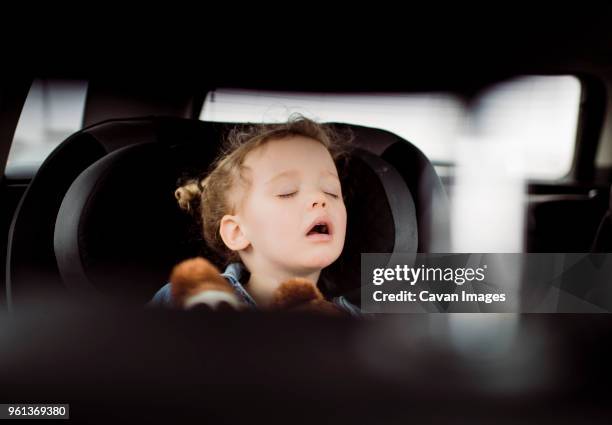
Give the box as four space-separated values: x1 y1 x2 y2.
170 257 344 315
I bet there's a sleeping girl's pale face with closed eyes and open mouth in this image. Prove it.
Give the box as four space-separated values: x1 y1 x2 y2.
238 136 346 273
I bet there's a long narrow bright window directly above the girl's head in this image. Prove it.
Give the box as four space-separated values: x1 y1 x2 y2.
200 89 464 168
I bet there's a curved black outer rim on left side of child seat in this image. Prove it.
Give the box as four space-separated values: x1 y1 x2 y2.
6 119 158 306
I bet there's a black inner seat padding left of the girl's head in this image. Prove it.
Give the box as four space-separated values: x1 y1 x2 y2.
55 143 216 302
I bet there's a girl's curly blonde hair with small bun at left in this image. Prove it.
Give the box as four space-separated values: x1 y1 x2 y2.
174 115 352 264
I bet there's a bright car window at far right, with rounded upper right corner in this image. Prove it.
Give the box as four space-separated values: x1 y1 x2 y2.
470 76 582 180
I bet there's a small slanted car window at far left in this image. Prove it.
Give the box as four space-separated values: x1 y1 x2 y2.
5 79 87 178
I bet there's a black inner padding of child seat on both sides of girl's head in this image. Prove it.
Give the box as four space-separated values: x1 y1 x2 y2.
55 140 418 303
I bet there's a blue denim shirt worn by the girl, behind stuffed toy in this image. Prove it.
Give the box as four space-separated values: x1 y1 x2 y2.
147 263 363 317
